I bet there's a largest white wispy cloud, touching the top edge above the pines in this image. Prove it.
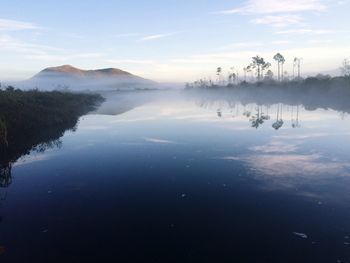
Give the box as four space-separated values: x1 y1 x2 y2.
218 0 327 15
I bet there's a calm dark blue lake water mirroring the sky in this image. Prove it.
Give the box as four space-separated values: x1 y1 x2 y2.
0 92 350 262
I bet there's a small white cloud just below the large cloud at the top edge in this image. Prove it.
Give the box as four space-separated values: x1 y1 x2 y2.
252 14 303 27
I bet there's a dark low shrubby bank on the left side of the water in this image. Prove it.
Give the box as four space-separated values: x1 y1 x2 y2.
0 87 103 179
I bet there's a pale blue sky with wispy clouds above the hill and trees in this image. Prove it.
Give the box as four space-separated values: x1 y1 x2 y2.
0 0 350 82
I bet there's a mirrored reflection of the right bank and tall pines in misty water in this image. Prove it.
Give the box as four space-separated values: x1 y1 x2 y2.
186 89 350 130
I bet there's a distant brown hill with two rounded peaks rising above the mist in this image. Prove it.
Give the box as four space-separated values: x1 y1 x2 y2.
17 65 156 91
